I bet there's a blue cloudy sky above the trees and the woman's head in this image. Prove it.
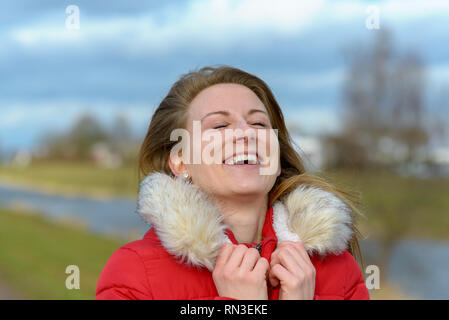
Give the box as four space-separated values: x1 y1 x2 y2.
0 0 449 150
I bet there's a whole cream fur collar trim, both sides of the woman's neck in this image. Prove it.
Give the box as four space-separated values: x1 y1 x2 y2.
137 172 353 271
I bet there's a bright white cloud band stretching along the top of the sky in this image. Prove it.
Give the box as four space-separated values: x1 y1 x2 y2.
5 0 449 52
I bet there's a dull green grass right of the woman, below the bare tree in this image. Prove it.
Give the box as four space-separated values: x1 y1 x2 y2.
326 170 449 240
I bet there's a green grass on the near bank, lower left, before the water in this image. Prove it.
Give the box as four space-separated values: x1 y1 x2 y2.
0 209 126 300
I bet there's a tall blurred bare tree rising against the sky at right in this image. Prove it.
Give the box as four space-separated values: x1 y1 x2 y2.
334 29 428 167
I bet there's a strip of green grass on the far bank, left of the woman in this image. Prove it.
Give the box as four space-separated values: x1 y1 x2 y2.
0 162 138 198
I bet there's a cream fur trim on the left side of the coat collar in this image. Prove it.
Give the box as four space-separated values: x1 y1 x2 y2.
137 173 227 270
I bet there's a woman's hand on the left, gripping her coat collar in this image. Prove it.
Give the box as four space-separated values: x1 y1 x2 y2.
212 243 270 300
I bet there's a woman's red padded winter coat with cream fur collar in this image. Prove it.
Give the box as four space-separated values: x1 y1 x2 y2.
96 173 369 300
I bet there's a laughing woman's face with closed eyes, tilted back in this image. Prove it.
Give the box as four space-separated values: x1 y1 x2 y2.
171 83 280 198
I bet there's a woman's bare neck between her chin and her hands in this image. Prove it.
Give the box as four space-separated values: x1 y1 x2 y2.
212 195 268 243
